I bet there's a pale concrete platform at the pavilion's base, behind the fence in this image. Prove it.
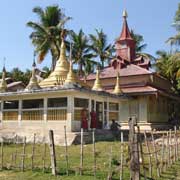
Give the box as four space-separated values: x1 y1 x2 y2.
0 127 124 146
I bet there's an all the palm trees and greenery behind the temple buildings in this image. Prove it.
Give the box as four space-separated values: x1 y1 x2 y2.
1 4 180 94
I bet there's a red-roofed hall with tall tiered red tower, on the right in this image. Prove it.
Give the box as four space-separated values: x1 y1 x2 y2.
86 11 180 129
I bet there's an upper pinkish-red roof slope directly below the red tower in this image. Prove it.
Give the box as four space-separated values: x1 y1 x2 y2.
87 64 152 80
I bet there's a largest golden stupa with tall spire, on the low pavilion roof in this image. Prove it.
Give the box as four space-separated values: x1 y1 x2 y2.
39 31 69 87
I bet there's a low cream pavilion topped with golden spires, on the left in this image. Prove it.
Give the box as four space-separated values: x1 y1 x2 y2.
0 31 128 135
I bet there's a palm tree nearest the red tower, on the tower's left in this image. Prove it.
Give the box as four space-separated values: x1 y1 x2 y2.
89 29 114 68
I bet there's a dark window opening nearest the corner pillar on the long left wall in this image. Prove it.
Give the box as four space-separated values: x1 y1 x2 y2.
48 97 67 108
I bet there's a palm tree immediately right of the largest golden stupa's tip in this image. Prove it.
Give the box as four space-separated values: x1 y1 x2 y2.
70 29 96 76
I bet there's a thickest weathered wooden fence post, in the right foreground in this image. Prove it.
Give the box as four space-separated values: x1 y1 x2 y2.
129 118 140 180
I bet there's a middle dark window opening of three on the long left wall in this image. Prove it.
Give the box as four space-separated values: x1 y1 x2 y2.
22 99 44 109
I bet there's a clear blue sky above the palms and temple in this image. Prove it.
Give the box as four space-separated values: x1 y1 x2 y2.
0 0 179 70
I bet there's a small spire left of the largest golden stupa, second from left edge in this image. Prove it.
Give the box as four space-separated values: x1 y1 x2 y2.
25 54 41 90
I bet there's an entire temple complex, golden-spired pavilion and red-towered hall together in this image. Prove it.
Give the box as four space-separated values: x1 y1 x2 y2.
0 11 180 138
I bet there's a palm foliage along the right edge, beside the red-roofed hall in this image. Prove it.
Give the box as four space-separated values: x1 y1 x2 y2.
156 3 180 94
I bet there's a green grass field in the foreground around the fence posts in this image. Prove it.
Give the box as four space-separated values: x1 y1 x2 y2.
0 141 180 180
